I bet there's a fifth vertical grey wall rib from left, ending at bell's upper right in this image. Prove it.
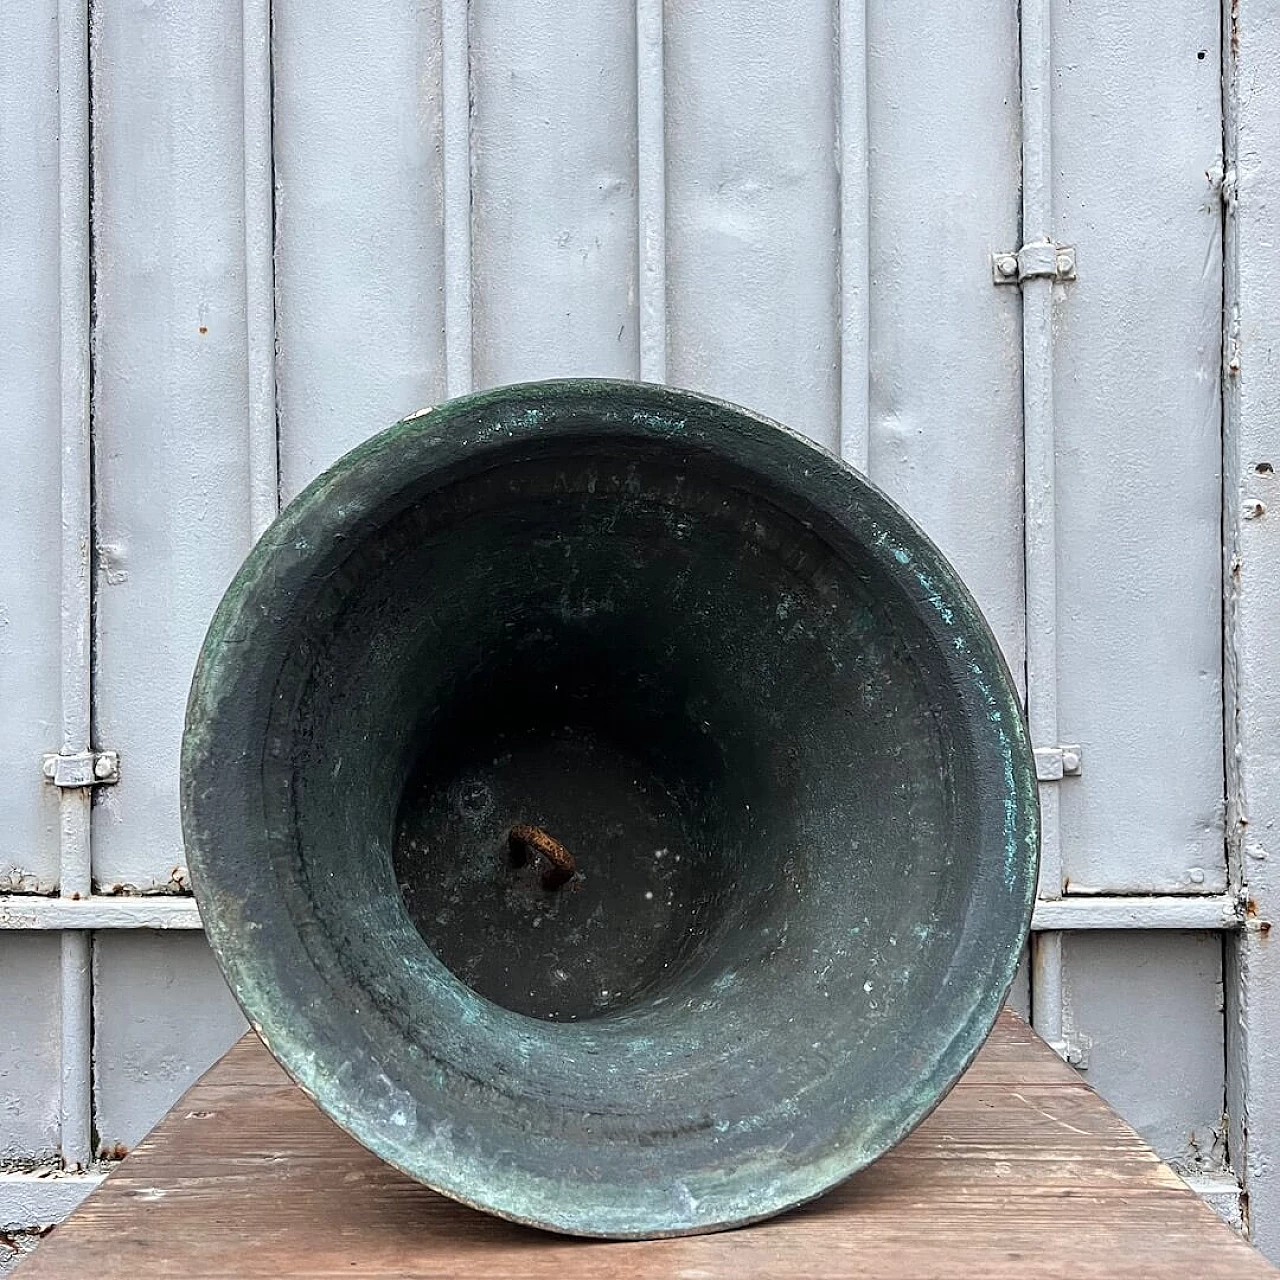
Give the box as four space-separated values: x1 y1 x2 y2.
836 0 870 474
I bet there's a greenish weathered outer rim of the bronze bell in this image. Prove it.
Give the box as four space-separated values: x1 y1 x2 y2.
182 379 1039 1239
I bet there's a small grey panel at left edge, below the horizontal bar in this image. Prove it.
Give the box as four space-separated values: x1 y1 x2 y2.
0 933 60 1162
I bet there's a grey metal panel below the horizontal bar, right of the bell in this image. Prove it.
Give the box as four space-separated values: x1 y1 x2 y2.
1064 933 1226 1172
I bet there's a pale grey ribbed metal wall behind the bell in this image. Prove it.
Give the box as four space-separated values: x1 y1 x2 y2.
0 0 1269 1259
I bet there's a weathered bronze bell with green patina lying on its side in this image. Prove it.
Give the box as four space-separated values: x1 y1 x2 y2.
183 381 1038 1238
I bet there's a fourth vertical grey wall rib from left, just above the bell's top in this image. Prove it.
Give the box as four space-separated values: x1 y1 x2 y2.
636 0 667 383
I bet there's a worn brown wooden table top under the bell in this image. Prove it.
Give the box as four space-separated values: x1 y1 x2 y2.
15 1011 1280 1280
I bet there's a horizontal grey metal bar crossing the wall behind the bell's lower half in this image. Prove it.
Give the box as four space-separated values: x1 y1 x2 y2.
0 893 1244 932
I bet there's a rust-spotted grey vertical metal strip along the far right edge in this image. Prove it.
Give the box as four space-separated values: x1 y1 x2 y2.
1222 0 1280 1261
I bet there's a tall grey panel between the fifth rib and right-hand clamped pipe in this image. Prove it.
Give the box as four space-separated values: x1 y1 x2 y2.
868 0 1024 678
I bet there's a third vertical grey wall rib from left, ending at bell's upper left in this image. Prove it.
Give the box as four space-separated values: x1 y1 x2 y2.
440 0 474 397
